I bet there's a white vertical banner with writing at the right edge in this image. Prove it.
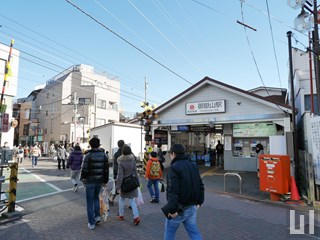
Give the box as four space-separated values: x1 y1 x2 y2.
310 117 320 185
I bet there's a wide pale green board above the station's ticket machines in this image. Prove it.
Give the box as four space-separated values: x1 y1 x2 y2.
233 123 277 137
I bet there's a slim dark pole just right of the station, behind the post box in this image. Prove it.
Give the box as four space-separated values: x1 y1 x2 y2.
287 31 300 186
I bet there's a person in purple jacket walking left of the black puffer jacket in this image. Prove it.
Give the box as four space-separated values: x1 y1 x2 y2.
67 146 83 192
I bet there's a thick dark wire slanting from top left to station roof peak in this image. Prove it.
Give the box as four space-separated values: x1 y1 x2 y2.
66 0 192 85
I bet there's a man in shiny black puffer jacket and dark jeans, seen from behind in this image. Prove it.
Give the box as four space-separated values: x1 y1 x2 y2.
81 138 109 230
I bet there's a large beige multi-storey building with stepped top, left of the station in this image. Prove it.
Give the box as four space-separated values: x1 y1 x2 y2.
33 64 120 146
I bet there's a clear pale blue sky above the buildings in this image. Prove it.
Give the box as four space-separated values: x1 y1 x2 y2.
0 0 308 117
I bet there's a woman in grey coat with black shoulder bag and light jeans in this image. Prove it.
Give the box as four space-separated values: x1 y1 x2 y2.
116 145 140 225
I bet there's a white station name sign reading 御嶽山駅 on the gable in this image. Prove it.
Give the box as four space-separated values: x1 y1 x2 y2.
186 100 226 115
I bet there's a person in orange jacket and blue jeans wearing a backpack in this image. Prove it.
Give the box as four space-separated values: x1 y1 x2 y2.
145 152 162 203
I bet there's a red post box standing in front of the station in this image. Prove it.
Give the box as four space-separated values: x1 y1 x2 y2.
259 154 290 201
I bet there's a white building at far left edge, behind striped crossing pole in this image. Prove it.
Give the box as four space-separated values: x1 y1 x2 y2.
0 40 20 147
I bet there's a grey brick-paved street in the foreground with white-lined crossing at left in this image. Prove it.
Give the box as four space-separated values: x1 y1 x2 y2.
0 159 320 240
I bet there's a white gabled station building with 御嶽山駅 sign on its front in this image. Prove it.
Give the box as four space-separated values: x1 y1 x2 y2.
152 77 293 171
